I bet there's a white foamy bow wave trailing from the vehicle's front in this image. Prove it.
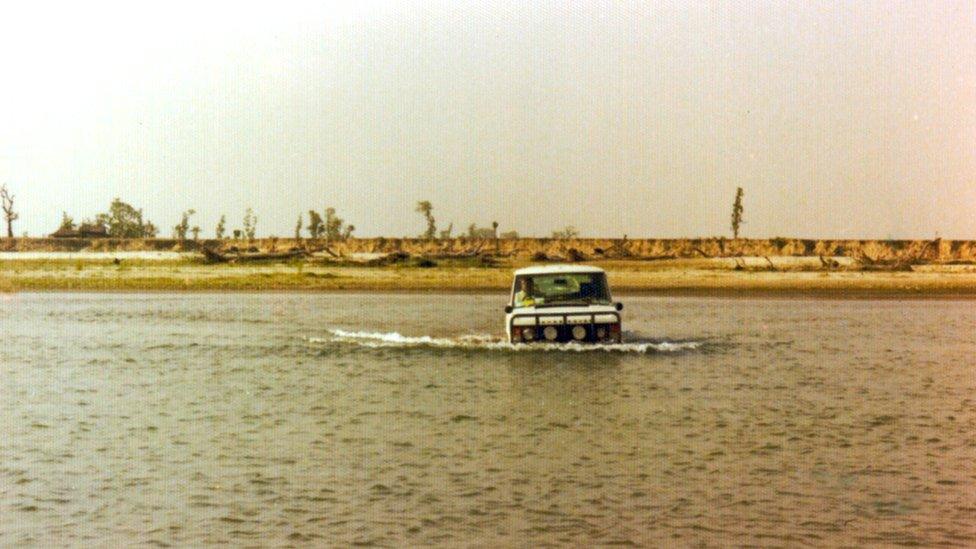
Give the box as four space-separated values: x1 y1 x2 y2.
308 330 701 353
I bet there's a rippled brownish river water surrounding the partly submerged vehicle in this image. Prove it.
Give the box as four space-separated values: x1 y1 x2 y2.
0 293 976 546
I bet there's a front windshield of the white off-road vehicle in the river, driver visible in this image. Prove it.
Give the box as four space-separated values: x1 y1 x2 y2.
512 273 610 307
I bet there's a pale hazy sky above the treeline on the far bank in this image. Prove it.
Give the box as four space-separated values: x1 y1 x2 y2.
0 0 976 238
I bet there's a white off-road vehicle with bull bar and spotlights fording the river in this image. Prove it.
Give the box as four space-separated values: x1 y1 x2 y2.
505 265 623 343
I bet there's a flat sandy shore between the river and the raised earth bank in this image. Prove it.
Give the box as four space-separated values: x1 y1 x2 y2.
0 254 976 298
